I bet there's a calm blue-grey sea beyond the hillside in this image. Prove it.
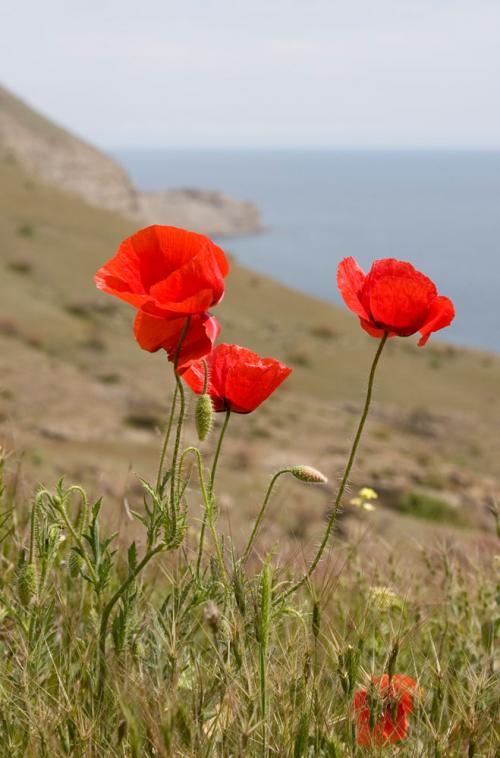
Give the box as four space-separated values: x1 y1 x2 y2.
113 149 500 352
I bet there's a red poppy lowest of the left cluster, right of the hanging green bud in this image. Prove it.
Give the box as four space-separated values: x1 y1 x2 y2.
182 344 292 413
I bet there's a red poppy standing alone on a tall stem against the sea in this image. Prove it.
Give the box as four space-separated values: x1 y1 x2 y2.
337 257 455 346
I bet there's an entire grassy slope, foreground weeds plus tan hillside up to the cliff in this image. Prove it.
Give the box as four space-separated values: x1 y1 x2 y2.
0 129 500 758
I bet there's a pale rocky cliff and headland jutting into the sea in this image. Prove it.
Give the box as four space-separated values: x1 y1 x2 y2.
0 86 260 236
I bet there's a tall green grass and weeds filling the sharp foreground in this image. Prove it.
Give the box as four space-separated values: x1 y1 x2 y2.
0 452 499 758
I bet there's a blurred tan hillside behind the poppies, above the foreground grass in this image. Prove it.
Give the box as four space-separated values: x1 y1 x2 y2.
0 150 500 556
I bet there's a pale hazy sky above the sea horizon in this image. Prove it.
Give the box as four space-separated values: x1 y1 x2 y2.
0 0 500 147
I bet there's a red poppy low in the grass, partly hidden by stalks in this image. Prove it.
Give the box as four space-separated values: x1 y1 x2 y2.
354 674 418 746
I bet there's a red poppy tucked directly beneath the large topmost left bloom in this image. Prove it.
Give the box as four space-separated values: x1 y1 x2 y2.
134 311 220 373
